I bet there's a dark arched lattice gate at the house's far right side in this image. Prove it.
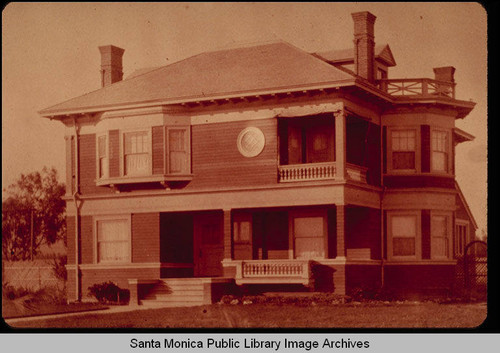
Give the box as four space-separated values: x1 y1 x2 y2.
463 240 488 299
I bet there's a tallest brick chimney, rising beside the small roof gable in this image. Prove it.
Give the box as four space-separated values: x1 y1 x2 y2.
351 11 376 82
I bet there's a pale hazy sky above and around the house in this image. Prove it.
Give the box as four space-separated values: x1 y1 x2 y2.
2 2 488 236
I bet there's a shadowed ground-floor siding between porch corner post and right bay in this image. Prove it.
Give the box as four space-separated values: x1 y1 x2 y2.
346 207 380 259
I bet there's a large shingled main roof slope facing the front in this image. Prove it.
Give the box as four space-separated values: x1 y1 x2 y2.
39 41 354 116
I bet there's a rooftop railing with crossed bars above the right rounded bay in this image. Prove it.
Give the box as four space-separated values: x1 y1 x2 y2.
377 78 455 98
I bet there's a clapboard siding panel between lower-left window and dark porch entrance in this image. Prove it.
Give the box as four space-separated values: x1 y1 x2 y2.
131 213 160 263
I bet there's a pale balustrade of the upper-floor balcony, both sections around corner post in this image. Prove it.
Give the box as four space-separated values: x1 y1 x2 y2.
278 162 367 183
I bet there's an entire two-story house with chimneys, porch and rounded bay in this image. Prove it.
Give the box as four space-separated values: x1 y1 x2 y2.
40 12 477 302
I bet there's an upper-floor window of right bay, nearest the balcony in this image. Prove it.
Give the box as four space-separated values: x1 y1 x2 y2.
391 129 417 170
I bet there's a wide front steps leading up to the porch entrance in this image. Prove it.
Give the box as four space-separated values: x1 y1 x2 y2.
139 277 234 307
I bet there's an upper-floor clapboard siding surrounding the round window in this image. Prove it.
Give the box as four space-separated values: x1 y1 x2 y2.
186 119 278 189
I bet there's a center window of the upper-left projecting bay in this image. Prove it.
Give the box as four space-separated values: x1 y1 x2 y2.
123 131 151 175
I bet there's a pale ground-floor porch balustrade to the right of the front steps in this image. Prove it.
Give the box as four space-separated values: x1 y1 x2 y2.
234 259 312 285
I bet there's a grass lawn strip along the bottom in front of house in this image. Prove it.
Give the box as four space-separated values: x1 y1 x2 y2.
5 302 486 328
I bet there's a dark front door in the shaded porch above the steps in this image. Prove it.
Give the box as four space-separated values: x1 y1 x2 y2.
194 213 224 277
